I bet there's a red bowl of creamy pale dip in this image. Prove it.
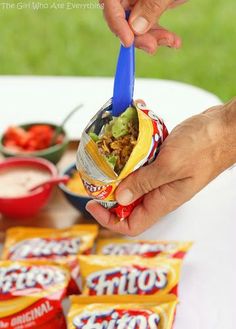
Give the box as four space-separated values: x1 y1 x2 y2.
0 158 57 219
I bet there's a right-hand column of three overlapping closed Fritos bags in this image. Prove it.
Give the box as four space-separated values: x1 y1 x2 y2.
68 238 192 329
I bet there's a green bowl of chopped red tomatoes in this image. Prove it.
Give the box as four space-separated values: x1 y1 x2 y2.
0 122 68 164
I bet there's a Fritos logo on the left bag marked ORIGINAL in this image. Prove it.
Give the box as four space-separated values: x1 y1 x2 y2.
0 264 65 300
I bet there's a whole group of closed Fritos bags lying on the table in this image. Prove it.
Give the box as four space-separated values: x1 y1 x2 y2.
0 225 191 329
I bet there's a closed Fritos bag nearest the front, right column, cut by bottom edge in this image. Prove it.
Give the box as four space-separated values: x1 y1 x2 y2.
68 296 177 329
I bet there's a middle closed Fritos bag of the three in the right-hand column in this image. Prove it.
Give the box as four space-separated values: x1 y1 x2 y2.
78 255 182 297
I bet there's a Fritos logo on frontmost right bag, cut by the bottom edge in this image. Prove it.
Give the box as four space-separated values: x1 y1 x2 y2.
73 309 160 329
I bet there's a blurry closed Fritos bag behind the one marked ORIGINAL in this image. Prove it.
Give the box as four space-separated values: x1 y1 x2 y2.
2 225 98 294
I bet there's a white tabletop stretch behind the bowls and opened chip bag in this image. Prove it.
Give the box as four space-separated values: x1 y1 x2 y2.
0 77 220 139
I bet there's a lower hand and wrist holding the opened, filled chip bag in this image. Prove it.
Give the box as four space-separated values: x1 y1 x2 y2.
87 100 236 236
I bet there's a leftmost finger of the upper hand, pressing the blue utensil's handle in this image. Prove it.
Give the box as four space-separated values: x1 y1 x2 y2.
101 0 134 47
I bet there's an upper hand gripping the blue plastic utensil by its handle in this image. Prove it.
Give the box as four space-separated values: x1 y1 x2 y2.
100 0 186 54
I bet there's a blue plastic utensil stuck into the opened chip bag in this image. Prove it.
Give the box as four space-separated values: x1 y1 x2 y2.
112 13 135 117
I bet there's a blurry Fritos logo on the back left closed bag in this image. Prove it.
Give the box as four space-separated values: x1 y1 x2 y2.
9 237 81 260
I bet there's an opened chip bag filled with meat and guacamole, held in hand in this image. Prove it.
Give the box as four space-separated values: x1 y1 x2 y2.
77 100 168 219
